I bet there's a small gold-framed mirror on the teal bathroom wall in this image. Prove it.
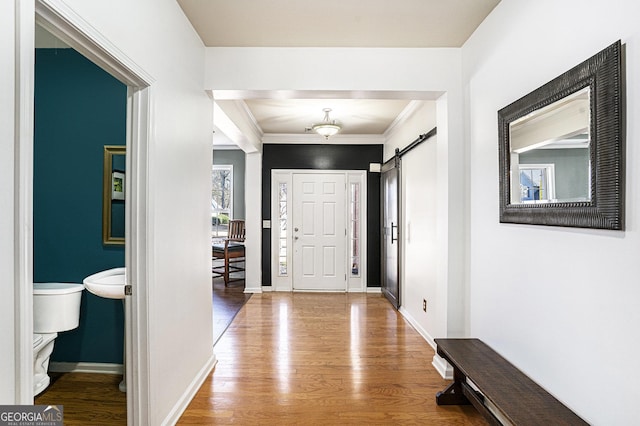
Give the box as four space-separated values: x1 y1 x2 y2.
102 145 126 245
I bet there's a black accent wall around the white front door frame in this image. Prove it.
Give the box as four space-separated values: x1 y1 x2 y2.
262 144 383 287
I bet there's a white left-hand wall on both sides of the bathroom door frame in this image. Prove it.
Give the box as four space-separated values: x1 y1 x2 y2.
0 0 214 424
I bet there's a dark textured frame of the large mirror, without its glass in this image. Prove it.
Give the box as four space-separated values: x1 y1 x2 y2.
498 40 625 230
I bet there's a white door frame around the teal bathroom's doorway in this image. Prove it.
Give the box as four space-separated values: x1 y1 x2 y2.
15 0 154 424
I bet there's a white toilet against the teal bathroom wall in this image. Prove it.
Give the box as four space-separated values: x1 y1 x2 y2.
33 283 84 396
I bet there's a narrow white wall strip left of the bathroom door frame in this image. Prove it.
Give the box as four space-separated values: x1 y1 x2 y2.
0 1 18 404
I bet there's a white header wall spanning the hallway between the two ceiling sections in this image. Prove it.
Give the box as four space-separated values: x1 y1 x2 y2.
205 47 460 95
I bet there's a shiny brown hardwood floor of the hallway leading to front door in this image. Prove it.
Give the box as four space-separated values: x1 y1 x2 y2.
178 293 486 425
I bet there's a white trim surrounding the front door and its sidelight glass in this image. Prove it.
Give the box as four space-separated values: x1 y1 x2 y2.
270 169 367 292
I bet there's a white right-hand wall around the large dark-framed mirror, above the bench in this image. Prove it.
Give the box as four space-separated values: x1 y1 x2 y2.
463 0 640 425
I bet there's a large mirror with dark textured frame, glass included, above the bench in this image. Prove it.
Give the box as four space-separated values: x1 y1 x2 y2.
498 41 624 230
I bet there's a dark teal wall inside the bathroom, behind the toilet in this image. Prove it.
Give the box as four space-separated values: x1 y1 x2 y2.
33 49 127 363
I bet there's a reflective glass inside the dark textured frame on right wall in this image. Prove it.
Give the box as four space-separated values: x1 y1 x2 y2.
509 87 591 204
